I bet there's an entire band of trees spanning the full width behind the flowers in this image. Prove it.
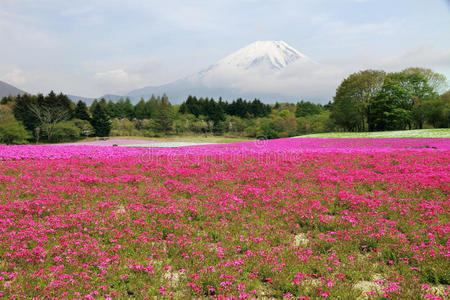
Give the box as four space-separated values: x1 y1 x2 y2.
0 68 450 144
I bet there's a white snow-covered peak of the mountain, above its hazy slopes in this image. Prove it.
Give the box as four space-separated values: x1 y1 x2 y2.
216 41 307 70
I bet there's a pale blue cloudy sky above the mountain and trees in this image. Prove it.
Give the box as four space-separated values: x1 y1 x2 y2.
0 0 450 97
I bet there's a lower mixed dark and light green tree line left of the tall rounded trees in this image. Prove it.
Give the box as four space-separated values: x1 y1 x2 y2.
0 92 333 144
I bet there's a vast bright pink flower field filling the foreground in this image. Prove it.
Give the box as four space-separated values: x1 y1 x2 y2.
0 139 450 299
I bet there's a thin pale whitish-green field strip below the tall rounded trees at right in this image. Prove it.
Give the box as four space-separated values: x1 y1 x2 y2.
298 128 450 138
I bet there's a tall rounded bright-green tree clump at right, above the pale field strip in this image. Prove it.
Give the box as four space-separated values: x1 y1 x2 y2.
330 68 449 132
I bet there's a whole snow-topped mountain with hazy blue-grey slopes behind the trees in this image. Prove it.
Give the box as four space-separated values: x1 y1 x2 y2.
126 41 317 104
